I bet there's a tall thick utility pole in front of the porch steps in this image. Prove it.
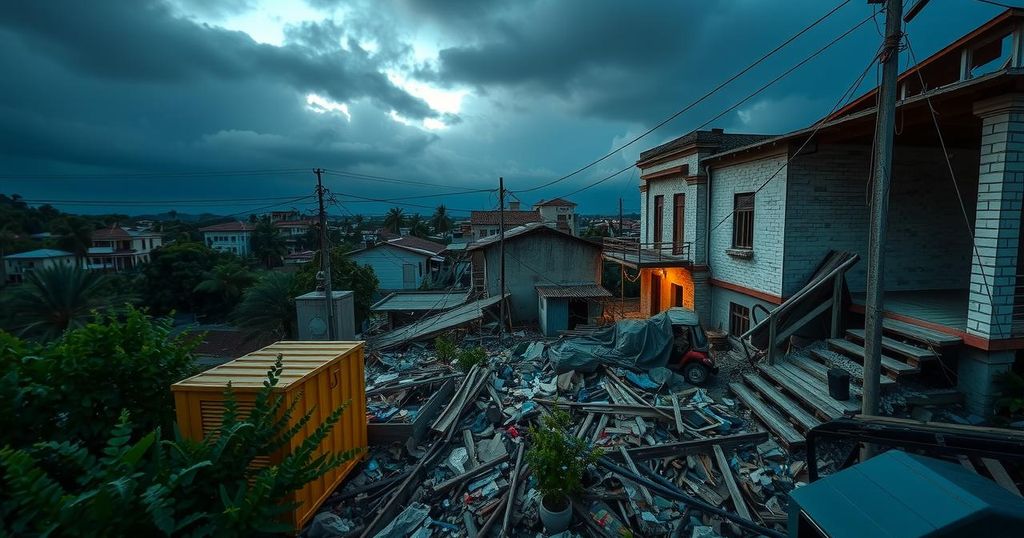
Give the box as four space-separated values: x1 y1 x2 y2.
861 0 903 436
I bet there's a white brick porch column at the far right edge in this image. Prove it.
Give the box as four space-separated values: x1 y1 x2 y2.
967 94 1024 339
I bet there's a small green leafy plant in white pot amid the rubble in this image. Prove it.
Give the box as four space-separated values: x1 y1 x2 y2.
526 409 601 534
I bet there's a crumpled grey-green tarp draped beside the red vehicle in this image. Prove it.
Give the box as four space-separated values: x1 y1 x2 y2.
548 314 673 374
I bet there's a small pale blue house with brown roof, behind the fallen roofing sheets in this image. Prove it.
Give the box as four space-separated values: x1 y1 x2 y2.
349 235 445 291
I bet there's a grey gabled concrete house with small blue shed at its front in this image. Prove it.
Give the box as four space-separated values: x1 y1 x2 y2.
467 222 610 327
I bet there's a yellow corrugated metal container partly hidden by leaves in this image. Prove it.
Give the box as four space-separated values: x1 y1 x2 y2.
171 341 367 530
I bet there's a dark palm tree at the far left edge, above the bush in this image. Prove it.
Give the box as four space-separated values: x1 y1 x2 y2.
3 264 118 340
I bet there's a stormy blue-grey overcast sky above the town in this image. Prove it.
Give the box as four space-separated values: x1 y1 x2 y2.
0 0 1000 214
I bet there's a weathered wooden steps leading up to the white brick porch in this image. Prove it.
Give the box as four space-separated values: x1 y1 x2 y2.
729 320 961 449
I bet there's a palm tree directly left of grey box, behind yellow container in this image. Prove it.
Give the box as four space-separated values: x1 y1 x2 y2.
231 272 296 339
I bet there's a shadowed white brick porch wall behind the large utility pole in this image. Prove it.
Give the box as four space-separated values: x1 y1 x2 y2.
782 146 979 296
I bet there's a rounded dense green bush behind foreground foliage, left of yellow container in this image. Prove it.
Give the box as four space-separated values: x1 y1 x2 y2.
0 307 197 452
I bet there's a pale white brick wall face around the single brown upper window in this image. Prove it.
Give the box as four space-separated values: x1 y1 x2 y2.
708 154 786 297
